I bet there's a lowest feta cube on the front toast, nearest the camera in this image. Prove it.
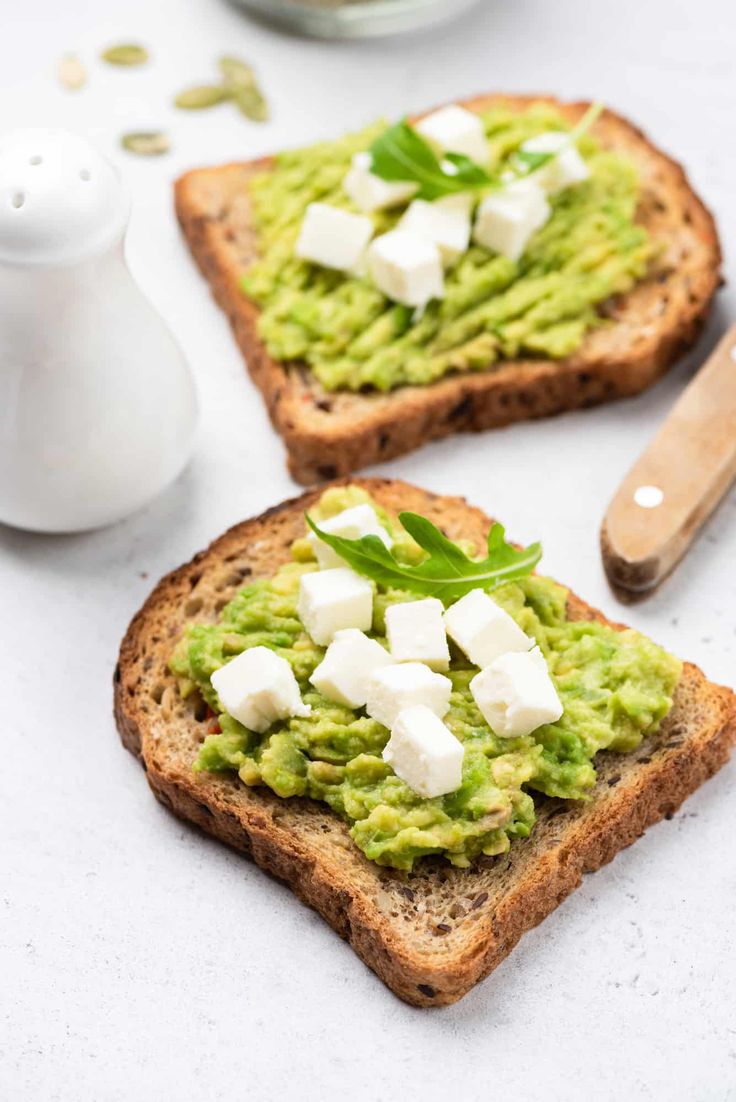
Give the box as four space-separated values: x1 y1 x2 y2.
383 704 464 799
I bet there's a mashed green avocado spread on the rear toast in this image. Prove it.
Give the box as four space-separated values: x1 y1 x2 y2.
242 104 653 390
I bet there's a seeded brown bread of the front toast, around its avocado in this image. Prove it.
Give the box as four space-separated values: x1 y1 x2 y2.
115 479 736 1006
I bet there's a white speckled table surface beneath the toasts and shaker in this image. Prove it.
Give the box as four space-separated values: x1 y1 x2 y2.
0 0 736 1102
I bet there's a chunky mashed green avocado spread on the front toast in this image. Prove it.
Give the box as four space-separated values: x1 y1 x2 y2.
171 487 680 869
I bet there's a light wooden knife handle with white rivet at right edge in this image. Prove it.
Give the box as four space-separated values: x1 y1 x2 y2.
600 325 736 593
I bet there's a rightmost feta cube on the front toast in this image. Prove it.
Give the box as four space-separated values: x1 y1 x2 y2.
470 647 563 738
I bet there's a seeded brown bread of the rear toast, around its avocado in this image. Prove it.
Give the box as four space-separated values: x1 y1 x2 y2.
176 96 721 484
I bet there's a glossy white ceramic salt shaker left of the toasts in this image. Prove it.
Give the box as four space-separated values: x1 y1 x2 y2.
0 130 196 532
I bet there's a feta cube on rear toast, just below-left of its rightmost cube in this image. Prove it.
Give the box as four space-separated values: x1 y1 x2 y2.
473 180 550 260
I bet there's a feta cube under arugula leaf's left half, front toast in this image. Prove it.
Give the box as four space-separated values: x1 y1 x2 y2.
296 566 374 647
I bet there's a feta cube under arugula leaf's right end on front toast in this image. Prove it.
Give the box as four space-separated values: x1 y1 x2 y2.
445 590 533 670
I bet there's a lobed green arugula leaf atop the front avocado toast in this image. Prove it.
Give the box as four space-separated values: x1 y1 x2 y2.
306 512 542 604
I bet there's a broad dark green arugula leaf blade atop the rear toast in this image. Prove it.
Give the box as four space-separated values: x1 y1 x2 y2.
370 119 491 199
